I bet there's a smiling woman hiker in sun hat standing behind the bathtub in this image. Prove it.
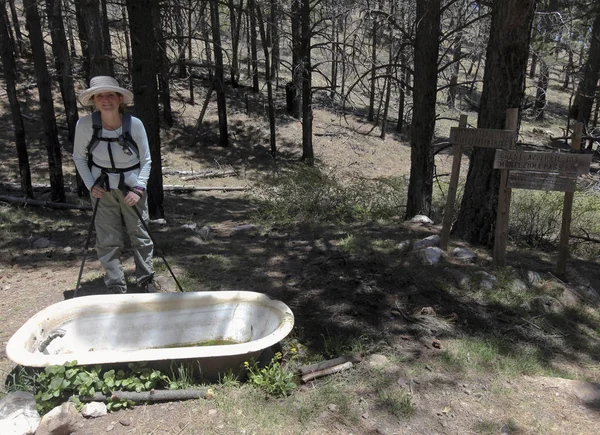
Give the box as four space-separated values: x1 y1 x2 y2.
73 76 158 293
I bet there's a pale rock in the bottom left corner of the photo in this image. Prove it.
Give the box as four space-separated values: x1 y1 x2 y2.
0 391 41 435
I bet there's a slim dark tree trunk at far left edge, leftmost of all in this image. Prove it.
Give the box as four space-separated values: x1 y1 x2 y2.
0 4 33 198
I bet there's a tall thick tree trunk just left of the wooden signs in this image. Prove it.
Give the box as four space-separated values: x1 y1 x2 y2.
406 0 441 218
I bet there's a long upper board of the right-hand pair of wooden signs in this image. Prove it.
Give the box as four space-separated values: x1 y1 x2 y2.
494 150 592 175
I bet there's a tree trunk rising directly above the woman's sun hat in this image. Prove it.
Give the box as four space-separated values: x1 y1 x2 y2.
75 0 113 78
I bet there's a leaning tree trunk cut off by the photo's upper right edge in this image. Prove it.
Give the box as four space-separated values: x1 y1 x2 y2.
570 12 600 125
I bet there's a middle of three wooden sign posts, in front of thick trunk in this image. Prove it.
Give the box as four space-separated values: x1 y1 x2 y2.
493 108 519 268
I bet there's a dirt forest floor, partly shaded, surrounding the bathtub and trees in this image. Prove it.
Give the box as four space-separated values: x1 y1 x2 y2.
0 79 600 435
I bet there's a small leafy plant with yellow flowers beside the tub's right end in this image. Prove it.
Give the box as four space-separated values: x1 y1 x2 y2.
244 348 297 397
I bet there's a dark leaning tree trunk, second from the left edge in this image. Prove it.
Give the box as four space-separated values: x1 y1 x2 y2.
23 0 65 202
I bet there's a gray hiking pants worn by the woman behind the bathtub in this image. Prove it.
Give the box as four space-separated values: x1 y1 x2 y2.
94 189 154 289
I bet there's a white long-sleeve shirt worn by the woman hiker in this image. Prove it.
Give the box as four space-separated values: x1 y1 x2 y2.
73 115 152 189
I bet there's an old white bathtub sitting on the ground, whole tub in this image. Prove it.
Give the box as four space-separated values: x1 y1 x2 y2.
6 291 294 378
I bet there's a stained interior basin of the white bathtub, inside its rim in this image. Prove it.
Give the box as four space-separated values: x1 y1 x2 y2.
25 298 285 356
